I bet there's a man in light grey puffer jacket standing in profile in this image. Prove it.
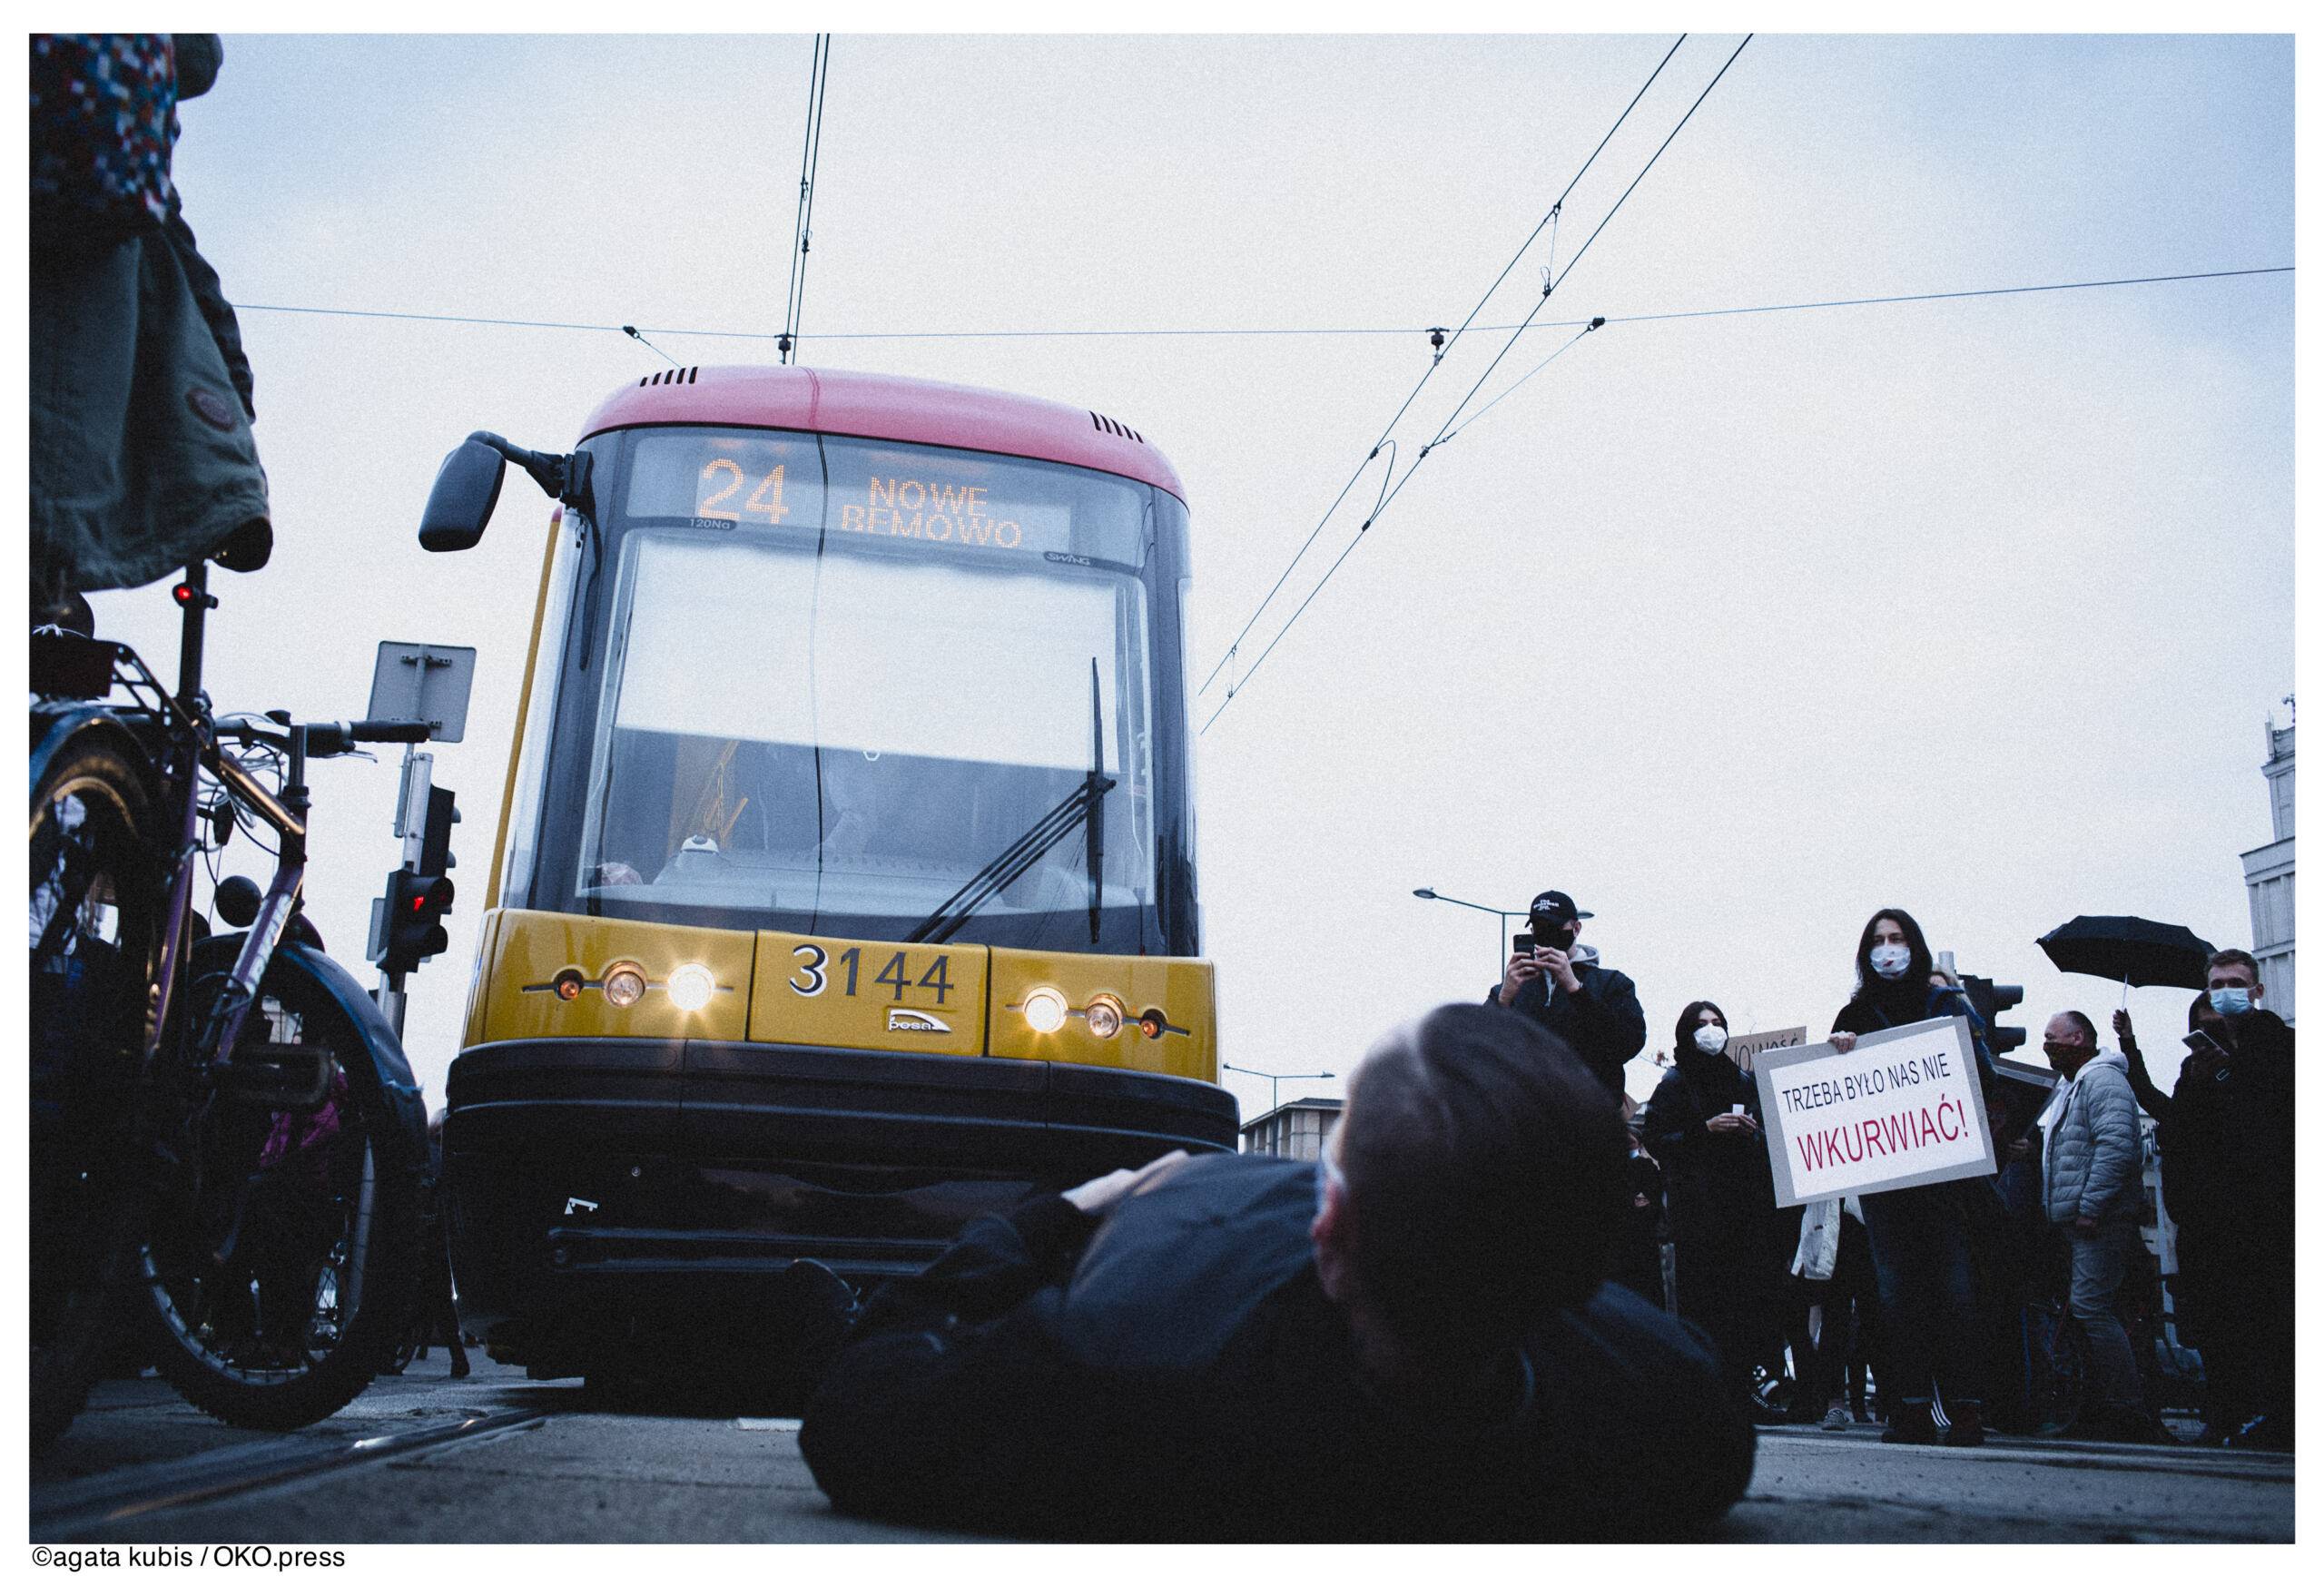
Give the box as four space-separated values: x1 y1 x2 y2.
2041 1010 2154 1440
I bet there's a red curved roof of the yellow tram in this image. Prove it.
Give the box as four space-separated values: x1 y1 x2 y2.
581 367 1186 499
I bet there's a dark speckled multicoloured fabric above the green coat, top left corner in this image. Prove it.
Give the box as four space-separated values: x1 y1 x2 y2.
33 33 179 234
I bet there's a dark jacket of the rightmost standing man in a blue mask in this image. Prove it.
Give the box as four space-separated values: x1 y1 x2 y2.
2157 1008 2296 1277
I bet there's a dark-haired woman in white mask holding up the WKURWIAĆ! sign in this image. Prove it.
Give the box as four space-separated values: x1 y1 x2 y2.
1831 908 1984 1444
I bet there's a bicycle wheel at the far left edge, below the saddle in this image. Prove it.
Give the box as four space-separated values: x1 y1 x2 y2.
28 734 161 1449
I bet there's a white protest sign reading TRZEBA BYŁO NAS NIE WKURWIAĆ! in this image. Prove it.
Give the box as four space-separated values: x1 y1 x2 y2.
1752 1017 1994 1206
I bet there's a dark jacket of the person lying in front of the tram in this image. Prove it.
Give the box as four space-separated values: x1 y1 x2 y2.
800 1157 1752 1543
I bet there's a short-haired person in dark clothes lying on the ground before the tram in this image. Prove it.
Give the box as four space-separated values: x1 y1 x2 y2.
800 1006 1752 1543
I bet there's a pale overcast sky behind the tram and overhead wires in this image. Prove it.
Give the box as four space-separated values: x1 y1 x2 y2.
77 34 2294 1115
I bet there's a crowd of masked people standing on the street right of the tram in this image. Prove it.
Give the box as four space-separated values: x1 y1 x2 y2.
1487 892 2291 1449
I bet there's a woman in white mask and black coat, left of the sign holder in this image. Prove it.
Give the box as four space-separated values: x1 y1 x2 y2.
1645 1001 1783 1424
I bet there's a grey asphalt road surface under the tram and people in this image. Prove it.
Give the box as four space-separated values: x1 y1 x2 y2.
30 1352 2291 1544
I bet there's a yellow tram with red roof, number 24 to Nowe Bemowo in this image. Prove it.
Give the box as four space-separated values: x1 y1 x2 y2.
420 367 1236 1377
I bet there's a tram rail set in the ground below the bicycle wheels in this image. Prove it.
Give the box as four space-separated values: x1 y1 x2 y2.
30 1407 548 1543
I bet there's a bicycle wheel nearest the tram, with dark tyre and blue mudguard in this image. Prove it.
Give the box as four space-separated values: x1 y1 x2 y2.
142 939 420 1428
